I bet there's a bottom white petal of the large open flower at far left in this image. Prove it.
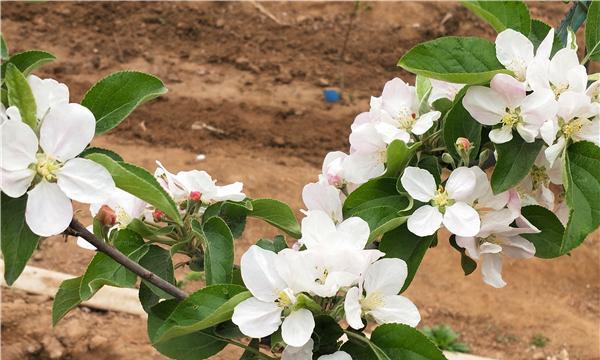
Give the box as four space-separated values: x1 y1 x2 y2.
25 181 73 236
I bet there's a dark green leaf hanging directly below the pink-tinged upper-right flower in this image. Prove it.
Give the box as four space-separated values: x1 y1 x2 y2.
491 138 544 194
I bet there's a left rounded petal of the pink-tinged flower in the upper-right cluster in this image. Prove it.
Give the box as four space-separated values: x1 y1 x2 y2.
462 86 507 125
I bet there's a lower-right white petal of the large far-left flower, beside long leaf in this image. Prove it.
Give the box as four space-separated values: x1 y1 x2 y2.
56 158 115 204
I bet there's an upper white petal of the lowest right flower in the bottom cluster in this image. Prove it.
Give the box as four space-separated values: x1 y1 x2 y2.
364 258 408 295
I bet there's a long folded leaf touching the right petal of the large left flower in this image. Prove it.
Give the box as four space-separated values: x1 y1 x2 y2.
86 153 181 224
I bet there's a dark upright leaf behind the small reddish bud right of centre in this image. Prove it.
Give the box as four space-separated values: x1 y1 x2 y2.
444 92 481 161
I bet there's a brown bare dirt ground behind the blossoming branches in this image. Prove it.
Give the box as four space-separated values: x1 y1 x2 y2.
1 2 600 360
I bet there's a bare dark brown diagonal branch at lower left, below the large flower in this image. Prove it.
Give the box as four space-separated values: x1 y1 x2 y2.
69 218 188 300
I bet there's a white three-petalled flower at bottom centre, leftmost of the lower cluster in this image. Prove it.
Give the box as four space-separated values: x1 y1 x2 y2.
231 245 315 347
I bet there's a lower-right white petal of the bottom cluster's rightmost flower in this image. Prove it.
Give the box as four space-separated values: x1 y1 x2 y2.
369 295 421 327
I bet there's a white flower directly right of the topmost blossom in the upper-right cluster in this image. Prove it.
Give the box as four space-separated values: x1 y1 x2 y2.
527 48 587 99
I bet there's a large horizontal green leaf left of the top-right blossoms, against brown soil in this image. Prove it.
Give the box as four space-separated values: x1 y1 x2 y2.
398 36 509 84
